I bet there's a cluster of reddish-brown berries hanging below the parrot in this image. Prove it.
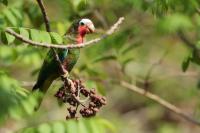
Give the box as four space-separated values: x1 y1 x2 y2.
55 80 106 119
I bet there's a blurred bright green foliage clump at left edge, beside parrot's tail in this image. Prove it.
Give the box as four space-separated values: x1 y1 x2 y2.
0 73 28 122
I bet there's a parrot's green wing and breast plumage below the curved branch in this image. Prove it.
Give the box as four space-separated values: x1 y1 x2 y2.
33 49 80 107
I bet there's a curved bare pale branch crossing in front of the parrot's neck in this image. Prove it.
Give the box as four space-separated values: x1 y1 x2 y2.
5 17 124 49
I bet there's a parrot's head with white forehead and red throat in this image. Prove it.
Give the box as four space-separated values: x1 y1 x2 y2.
67 18 95 43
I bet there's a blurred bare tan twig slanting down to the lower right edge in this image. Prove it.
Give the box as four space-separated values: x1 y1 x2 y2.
120 81 200 126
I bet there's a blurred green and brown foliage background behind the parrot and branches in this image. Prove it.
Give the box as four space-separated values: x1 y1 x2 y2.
0 0 200 133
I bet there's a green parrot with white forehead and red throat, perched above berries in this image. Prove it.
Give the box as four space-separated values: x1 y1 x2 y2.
32 18 95 110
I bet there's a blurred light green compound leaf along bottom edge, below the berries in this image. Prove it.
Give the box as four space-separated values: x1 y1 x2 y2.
17 118 115 133
